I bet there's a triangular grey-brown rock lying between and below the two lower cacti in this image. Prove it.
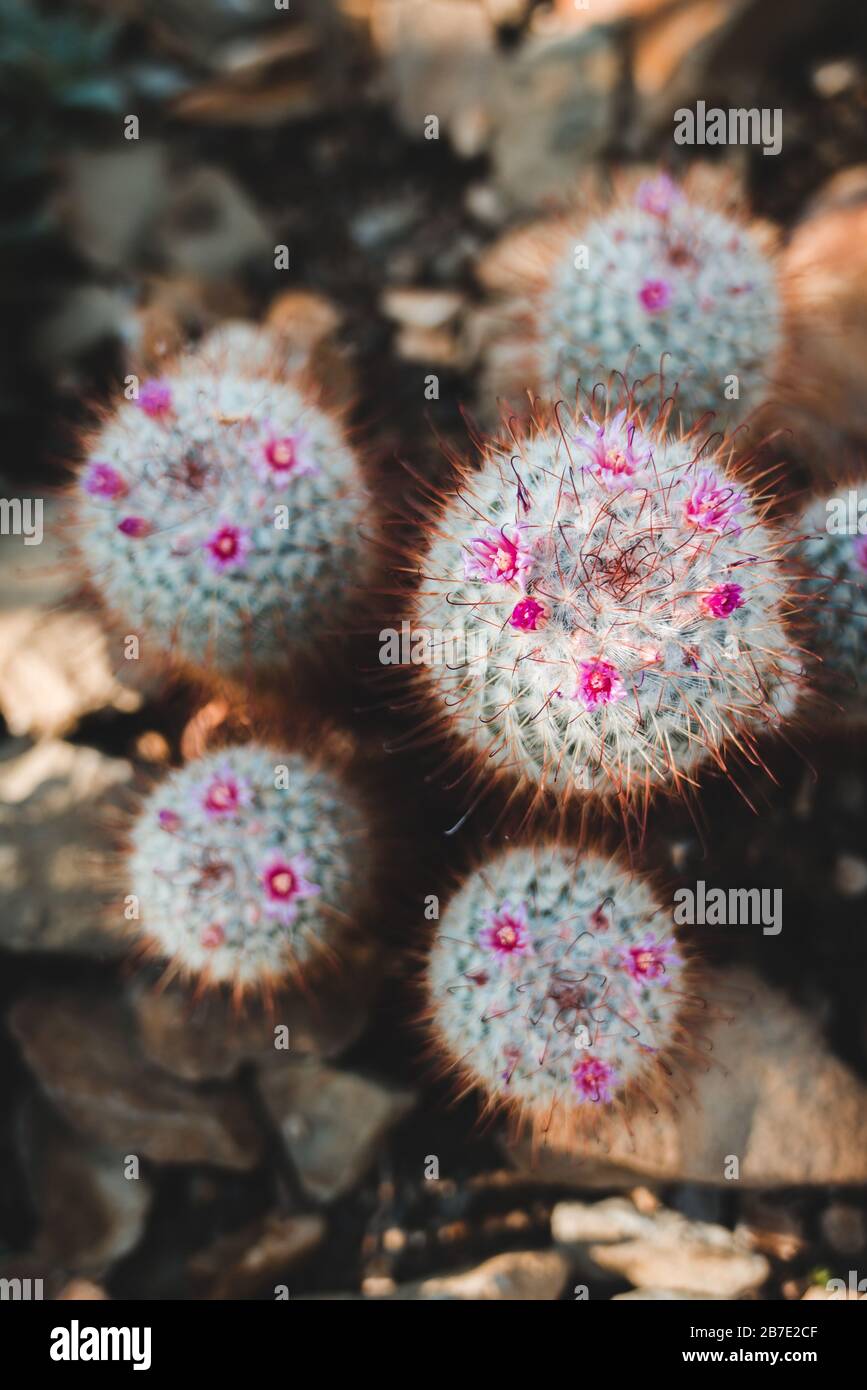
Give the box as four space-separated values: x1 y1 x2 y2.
260 1061 414 1202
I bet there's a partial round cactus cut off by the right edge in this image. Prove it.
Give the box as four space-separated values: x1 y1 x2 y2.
795 482 867 721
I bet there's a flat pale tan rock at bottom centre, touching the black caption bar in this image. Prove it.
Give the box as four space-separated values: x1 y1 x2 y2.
315 1250 570 1302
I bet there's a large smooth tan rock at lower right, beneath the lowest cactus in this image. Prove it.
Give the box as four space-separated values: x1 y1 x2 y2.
510 970 867 1189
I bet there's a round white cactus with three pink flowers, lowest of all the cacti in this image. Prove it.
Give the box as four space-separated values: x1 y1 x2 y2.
427 845 691 1129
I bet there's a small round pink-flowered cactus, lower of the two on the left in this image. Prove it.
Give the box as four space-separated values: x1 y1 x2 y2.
128 744 372 994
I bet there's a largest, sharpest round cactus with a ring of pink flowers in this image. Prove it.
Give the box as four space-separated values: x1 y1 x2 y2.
413 410 800 803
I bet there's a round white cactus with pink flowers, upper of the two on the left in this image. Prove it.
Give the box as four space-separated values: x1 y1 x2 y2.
78 356 368 674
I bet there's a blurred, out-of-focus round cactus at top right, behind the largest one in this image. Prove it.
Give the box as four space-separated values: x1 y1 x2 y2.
484 171 782 428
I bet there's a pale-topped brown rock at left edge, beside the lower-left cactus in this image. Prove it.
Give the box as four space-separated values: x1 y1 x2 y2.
0 741 132 956
